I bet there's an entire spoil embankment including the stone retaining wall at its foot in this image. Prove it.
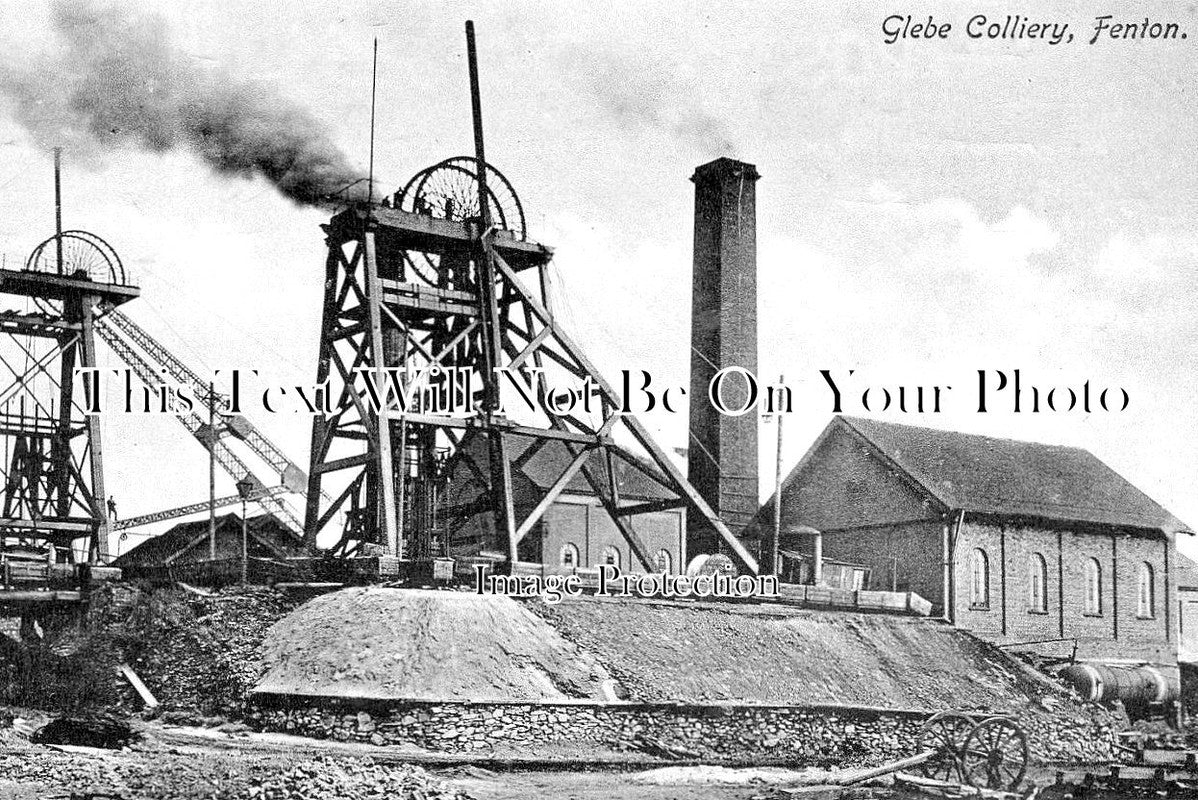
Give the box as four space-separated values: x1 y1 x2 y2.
249 588 1112 764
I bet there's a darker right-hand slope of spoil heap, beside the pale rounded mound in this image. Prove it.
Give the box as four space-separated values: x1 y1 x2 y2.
530 598 1046 711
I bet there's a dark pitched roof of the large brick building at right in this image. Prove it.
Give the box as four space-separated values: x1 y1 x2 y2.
800 417 1187 533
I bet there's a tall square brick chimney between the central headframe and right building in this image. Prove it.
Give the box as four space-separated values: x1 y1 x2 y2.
686 158 761 556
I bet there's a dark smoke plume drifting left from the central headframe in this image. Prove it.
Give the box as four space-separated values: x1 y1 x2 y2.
0 0 364 205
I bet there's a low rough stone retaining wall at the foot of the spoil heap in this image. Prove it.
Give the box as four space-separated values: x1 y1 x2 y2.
247 696 1113 766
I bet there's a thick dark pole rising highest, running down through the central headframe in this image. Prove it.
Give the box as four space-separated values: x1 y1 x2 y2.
466 20 518 565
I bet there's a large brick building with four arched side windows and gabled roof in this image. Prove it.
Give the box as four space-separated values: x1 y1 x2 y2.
752 417 1185 669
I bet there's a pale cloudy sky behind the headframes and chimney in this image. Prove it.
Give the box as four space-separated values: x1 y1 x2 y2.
0 0 1198 560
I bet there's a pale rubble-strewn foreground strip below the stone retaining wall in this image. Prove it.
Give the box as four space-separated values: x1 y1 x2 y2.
0 716 896 800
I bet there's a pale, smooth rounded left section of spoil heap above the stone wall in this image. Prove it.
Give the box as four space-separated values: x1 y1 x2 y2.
255 588 611 703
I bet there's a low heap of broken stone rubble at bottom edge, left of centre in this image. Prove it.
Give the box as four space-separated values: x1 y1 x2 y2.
235 757 470 800
